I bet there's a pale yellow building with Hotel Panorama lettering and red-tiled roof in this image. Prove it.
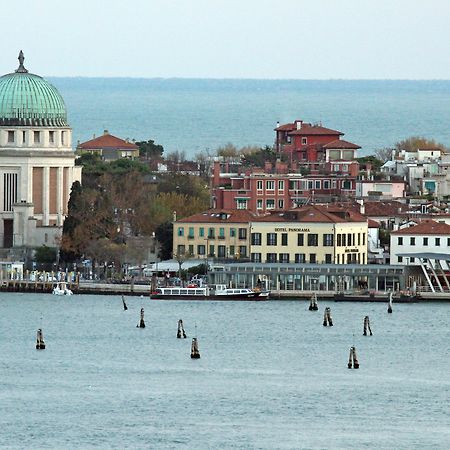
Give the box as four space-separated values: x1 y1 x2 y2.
250 205 368 264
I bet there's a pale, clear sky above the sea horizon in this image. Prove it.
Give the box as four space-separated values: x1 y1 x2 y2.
0 0 450 79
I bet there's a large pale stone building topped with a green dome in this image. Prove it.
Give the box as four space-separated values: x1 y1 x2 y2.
0 51 81 248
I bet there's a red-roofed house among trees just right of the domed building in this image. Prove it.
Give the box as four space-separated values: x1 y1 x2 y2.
76 130 139 161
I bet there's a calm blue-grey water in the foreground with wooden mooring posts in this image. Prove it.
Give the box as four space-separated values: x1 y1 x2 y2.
0 294 450 449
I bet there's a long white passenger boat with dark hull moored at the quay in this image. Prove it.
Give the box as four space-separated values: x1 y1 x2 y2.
150 284 269 300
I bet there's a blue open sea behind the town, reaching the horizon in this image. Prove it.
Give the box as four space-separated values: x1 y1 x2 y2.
49 78 450 158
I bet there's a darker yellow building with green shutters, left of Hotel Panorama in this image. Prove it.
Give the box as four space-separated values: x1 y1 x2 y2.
173 210 256 259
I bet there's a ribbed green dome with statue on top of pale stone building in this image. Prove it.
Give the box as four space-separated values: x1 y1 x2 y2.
0 52 68 127
